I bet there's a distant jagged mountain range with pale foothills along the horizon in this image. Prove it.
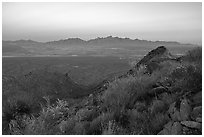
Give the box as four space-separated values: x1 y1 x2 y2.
2 36 198 56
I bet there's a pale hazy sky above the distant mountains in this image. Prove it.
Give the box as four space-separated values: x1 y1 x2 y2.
2 2 202 44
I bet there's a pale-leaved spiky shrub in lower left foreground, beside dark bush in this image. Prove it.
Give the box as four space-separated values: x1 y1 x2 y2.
9 100 73 135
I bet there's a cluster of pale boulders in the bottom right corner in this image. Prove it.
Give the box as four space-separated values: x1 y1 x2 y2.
158 98 202 135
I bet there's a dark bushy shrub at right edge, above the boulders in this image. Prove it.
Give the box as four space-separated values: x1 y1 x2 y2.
158 56 202 92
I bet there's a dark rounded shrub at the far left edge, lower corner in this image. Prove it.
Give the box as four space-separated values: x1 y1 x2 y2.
2 92 37 134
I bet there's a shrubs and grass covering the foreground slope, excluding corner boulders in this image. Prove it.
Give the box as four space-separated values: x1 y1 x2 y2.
3 48 202 135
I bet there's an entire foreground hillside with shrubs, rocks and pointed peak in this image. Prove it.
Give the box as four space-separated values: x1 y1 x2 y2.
3 46 202 135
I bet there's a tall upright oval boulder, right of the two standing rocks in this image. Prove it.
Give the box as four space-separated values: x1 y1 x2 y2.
180 99 191 121
